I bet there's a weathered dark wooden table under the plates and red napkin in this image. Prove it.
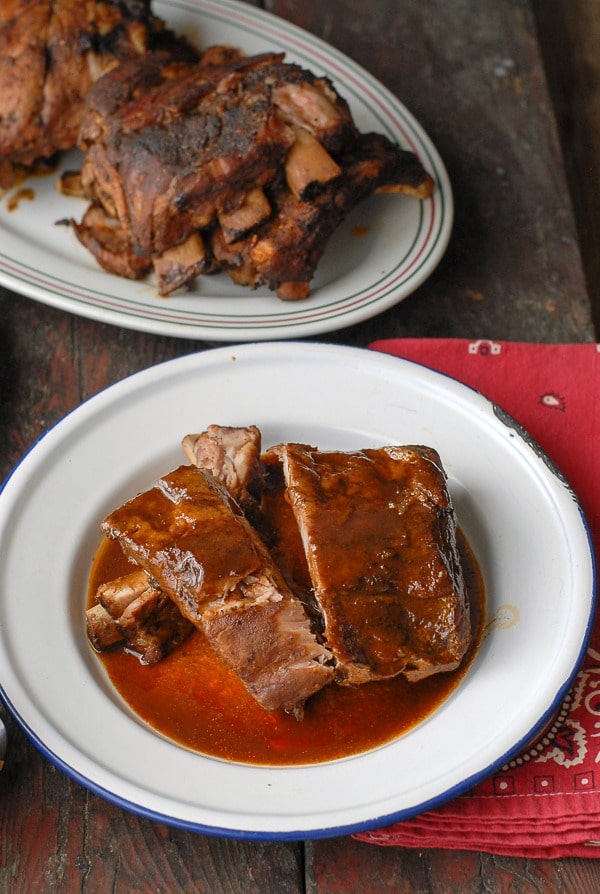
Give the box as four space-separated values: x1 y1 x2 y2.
0 0 600 894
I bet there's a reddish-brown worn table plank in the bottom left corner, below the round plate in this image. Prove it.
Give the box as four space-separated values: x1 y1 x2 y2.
0 711 303 894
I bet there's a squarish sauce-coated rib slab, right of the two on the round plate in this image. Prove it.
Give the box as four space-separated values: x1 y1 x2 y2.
269 444 470 685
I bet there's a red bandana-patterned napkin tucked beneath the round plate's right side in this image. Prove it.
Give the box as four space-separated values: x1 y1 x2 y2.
356 339 600 858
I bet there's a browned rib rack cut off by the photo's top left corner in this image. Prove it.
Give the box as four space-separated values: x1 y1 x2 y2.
0 0 196 185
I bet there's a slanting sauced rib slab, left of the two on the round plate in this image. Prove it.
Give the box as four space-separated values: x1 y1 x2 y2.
101 466 333 715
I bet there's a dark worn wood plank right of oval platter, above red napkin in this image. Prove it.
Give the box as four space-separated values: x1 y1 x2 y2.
267 0 593 342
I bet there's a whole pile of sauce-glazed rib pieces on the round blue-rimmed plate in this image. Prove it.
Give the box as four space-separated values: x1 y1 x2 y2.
86 425 471 716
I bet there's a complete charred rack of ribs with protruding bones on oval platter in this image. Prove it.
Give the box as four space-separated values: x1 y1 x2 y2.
71 47 433 299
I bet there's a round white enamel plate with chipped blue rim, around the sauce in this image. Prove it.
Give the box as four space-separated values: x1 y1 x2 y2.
0 342 595 838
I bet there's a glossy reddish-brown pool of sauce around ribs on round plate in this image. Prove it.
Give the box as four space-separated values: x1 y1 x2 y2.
89 535 484 766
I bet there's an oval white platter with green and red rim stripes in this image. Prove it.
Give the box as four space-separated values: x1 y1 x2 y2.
0 0 453 342
